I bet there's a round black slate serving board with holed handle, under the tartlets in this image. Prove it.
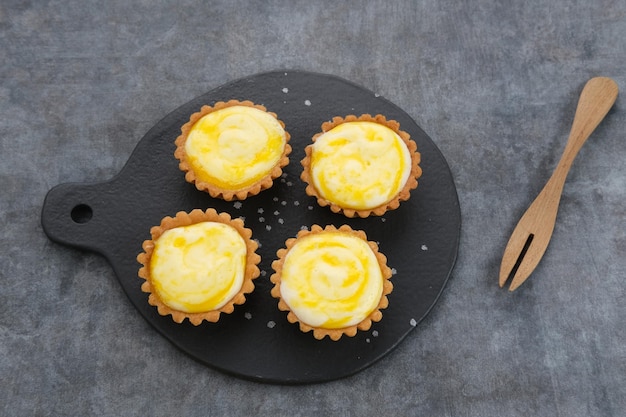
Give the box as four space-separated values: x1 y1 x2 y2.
42 71 461 384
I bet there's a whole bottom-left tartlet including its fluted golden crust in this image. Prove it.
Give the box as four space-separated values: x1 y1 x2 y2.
137 209 261 326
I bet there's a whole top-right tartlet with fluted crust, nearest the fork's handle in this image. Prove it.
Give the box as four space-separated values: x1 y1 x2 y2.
301 114 422 217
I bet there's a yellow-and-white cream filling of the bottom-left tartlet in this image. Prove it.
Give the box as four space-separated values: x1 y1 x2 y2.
150 222 247 313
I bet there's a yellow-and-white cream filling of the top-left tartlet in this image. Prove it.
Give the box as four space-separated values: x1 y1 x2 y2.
185 106 287 190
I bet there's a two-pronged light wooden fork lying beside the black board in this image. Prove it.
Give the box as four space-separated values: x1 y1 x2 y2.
500 77 618 291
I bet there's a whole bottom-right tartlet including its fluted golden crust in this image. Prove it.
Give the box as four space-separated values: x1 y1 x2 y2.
270 225 393 341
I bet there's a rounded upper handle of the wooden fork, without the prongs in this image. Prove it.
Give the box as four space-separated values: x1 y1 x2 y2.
550 77 618 188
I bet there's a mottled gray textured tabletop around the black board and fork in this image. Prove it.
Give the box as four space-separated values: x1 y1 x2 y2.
0 0 626 417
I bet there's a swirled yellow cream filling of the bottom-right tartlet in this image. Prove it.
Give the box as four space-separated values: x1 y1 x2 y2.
280 231 383 329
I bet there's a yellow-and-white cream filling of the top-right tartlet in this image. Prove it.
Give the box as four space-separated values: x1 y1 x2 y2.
311 121 411 210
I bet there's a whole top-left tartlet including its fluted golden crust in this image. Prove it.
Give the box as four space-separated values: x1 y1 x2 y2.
174 100 291 201
